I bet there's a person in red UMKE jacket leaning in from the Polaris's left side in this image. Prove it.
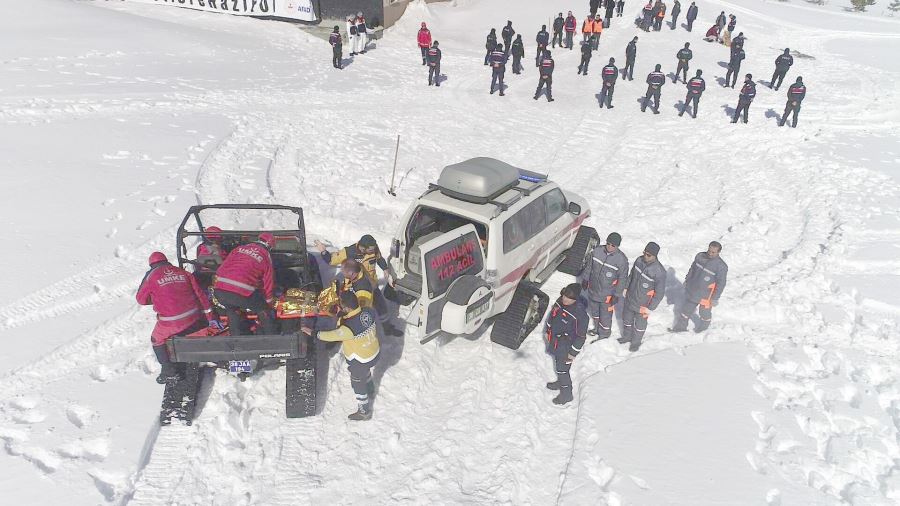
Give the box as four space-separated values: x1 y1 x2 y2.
136 251 221 383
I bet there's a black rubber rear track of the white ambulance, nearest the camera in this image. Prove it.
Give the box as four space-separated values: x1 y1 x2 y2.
491 280 550 350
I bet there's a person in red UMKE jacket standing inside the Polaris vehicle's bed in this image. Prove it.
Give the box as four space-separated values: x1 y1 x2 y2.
213 232 278 336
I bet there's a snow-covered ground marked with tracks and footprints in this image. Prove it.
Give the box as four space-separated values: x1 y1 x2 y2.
0 0 900 505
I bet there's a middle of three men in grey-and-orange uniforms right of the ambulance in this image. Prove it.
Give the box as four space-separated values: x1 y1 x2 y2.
619 242 666 352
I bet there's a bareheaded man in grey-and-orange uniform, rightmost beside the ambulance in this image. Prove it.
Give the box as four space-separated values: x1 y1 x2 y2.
670 241 728 332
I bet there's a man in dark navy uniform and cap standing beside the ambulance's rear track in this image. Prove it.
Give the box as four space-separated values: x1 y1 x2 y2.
544 283 590 405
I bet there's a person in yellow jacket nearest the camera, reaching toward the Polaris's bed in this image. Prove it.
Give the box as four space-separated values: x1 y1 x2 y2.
303 291 379 421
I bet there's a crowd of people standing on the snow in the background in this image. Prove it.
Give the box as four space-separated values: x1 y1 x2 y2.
329 0 806 127
